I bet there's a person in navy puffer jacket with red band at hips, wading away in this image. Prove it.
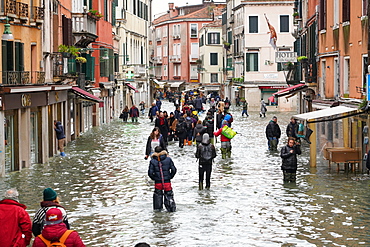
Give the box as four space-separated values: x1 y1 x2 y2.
148 146 177 212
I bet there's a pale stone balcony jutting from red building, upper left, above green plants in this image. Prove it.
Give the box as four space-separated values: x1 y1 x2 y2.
72 13 98 47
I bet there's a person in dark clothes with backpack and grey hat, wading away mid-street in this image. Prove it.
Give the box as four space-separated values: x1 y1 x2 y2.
195 133 216 190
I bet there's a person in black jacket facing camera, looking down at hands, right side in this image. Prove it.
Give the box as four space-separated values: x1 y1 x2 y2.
280 137 302 183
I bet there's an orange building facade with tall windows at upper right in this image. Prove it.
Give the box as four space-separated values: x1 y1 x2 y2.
317 0 368 100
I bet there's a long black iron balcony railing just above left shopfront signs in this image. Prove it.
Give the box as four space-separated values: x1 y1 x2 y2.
1 71 45 85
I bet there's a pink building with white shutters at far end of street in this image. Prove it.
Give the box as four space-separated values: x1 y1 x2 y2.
152 1 226 89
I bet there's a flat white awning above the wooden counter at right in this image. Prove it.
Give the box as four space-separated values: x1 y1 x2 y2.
293 106 362 123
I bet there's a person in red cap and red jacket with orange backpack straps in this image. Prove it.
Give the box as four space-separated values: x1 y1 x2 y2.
32 208 85 247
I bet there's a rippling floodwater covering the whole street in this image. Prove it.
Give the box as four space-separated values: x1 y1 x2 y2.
0 103 370 247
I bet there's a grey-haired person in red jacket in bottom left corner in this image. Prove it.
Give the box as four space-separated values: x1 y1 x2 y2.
0 189 32 247
